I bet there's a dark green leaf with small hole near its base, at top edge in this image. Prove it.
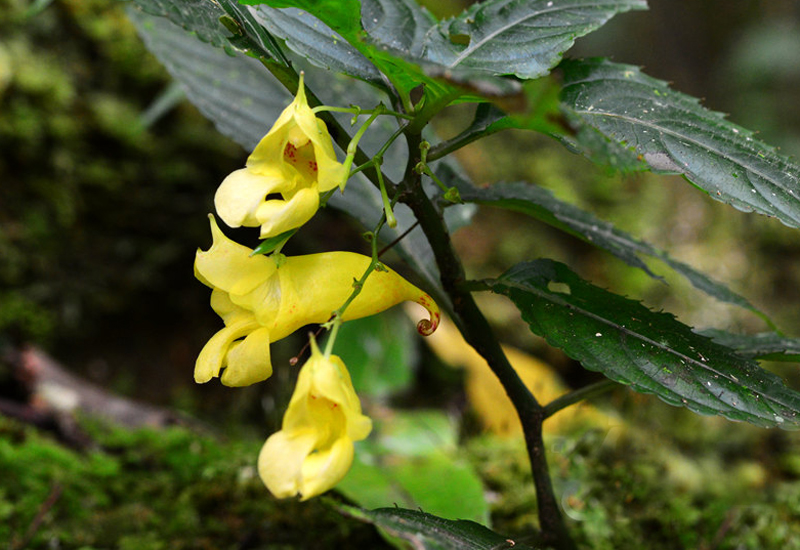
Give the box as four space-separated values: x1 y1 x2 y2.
424 0 647 79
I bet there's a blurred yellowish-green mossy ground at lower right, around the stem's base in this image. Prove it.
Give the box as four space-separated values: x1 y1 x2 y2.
467 397 800 550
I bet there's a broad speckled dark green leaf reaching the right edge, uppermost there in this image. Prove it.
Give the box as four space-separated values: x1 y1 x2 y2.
561 59 800 231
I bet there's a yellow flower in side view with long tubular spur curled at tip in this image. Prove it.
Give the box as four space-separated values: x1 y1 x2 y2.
194 217 440 386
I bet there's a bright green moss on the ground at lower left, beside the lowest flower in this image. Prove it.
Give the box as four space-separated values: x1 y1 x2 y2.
0 417 394 550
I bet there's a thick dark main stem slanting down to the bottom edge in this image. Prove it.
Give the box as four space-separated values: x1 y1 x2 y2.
400 134 575 550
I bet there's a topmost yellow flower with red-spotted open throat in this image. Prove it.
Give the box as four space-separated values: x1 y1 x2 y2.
214 77 346 239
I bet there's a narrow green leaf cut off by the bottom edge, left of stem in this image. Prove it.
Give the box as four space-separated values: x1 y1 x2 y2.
339 505 533 550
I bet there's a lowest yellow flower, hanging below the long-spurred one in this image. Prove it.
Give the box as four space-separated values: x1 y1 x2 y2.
258 339 372 500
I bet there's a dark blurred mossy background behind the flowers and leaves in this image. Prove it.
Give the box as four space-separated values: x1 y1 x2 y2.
0 0 800 548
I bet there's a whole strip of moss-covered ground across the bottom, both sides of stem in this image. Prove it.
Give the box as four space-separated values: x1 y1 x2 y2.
0 397 800 550
